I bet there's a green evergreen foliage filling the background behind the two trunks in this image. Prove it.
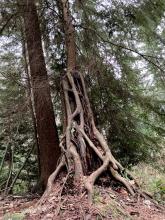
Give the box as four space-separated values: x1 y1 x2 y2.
0 0 165 192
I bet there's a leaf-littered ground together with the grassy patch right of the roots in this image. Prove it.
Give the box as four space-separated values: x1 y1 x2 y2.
0 163 165 220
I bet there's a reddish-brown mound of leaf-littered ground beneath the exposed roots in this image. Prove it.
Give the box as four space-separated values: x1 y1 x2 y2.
0 182 165 220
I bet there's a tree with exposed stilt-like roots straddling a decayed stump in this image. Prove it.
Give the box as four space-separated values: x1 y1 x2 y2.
41 0 137 203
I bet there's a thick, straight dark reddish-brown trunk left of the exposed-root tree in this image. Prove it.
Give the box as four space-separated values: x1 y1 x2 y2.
20 0 60 187
